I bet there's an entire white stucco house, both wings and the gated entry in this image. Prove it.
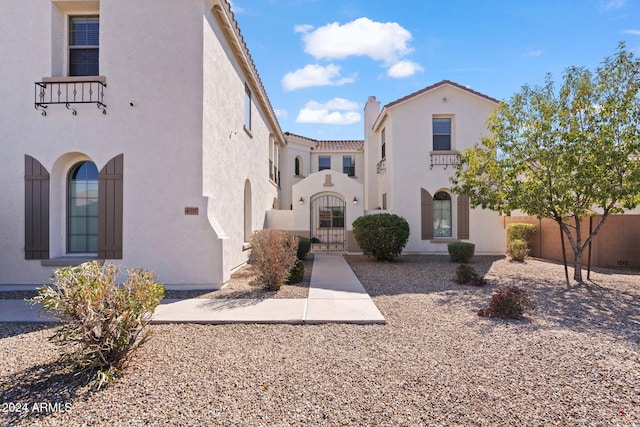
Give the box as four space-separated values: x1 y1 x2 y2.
0 0 505 288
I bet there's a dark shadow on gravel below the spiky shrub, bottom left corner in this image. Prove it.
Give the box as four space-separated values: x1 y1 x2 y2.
0 361 94 425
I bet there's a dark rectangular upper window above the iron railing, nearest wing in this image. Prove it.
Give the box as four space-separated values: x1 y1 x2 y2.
69 15 100 76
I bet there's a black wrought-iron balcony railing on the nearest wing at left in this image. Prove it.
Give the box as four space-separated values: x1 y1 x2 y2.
34 77 107 116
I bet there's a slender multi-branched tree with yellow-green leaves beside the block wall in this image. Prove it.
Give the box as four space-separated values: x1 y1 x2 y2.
452 43 640 282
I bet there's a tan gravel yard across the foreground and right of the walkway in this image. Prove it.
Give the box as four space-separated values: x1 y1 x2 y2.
0 255 640 426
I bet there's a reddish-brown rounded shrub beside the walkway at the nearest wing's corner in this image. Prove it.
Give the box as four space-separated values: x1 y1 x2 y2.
251 230 298 291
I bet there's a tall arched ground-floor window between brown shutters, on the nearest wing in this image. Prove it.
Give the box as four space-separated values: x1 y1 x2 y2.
67 162 98 253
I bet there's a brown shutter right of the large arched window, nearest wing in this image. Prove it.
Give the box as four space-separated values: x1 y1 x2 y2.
98 154 124 259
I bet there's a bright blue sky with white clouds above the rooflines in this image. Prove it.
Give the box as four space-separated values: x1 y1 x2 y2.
232 0 640 139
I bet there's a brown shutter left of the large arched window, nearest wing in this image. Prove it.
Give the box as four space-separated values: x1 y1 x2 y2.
24 155 49 259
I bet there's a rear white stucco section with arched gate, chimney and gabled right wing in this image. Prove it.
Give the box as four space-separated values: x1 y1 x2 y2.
267 81 505 254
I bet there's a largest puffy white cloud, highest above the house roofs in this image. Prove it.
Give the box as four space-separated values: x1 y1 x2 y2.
302 18 412 66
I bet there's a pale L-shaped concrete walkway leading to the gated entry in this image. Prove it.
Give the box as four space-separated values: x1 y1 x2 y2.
0 253 386 324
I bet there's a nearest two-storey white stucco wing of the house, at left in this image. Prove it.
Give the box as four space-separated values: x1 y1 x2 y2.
0 0 285 288
